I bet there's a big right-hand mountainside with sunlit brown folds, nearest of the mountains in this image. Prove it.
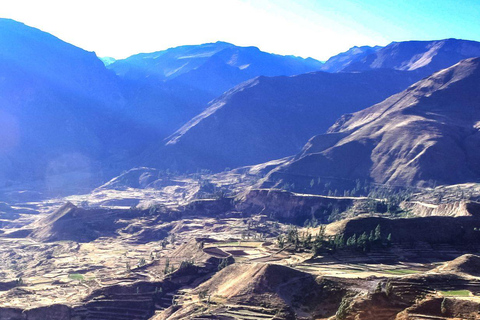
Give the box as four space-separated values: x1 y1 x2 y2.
265 58 480 186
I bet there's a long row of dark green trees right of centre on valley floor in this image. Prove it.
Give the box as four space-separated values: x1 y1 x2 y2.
277 225 392 256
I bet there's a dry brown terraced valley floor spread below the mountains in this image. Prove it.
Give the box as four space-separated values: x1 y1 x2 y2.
0 174 480 320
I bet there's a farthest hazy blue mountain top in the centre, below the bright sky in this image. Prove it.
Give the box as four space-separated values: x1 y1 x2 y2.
108 42 322 98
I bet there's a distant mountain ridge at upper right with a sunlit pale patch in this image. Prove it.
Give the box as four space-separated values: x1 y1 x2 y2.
342 39 480 77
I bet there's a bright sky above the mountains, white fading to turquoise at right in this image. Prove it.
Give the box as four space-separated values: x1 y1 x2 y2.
0 0 480 60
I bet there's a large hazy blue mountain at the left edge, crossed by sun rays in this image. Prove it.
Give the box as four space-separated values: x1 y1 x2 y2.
0 19 128 192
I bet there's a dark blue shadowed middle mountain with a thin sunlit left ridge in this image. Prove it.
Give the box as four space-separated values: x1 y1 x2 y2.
144 70 418 171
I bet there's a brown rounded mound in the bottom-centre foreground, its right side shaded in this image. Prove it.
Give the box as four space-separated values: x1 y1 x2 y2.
152 263 345 320
